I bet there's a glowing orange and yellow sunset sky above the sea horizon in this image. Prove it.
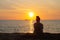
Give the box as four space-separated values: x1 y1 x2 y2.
0 0 60 20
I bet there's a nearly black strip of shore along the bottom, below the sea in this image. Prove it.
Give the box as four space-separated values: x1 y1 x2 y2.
0 33 60 40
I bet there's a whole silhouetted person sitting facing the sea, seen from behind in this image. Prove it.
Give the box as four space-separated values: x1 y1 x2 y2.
34 16 43 35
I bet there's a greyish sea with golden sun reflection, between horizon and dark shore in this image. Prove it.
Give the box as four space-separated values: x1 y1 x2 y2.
0 20 60 33
